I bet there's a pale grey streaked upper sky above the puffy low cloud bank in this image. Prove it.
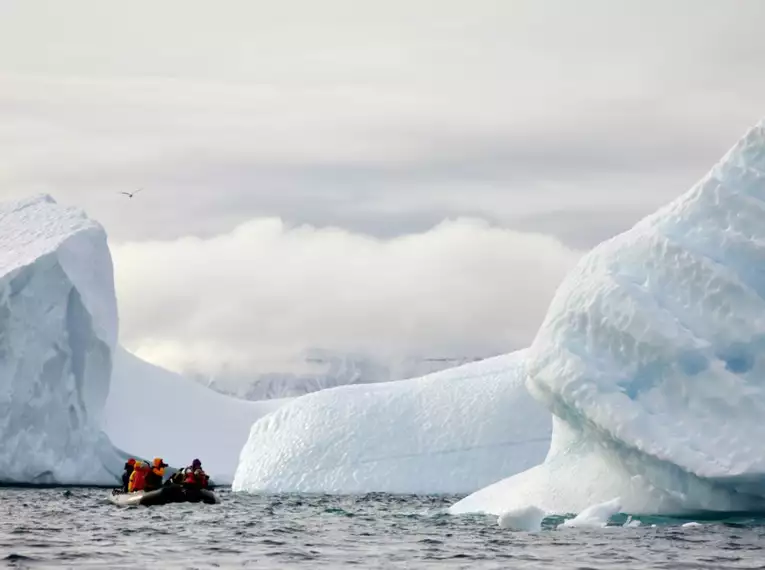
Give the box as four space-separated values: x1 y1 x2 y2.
0 0 765 247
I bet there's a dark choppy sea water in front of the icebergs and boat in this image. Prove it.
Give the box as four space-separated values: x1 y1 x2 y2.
0 488 765 570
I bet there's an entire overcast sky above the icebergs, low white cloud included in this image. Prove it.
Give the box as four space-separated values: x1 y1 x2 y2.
0 0 765 374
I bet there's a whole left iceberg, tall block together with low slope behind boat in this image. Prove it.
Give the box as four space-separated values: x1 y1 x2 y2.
0 196 283 485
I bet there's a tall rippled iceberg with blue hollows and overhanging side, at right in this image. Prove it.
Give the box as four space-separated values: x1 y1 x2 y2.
452 117 765 514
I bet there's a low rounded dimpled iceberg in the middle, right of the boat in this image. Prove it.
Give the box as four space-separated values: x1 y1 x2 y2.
233 352 551 493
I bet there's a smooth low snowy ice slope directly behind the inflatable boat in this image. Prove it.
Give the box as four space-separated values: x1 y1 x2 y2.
103 347 286 483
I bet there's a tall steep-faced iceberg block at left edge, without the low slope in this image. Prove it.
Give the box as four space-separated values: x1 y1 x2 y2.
0 196 120 483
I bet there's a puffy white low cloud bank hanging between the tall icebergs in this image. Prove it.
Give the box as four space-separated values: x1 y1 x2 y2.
113 219 579 374
